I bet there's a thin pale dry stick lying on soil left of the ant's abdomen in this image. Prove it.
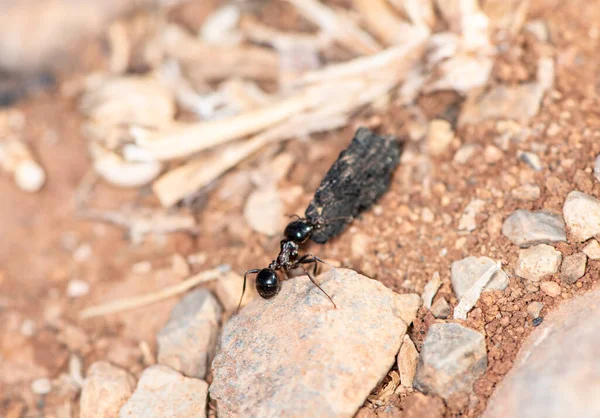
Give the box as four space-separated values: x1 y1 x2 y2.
79 268 224 319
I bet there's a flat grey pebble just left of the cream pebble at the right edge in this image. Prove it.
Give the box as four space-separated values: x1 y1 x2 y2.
502 209 567 247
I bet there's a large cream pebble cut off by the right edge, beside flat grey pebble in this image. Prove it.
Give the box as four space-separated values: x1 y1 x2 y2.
563 191 600 242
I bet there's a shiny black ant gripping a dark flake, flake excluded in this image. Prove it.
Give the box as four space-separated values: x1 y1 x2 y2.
238 215 351 311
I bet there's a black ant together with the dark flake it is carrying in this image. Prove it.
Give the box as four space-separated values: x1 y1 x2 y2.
238 128 402 310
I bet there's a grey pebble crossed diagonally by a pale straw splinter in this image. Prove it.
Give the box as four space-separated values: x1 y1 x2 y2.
451 256 508 300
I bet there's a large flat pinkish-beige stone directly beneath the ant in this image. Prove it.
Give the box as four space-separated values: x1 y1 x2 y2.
210 269 408 417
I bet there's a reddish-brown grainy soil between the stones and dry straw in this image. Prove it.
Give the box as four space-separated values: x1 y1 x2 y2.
0 0 600 417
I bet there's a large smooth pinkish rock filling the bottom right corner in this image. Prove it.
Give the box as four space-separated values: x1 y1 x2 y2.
483 289 600 418
